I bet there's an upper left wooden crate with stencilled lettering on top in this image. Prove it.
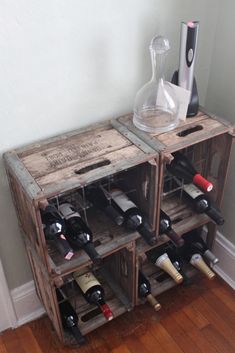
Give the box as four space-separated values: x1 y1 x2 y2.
4 122 159 276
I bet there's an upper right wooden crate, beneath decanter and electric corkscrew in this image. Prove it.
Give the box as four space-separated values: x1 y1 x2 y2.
118 110 234 246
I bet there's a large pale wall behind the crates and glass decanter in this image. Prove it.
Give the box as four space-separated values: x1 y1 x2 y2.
0 0 218 288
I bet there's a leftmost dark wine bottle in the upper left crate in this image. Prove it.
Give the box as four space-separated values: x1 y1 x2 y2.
39 201 74 260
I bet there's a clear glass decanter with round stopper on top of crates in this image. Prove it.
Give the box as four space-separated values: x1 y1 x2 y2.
133 36 179 133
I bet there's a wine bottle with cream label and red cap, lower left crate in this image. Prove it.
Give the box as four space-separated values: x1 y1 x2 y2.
73 271 113 321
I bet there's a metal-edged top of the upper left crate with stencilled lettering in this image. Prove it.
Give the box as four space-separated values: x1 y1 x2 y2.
4 121 157 197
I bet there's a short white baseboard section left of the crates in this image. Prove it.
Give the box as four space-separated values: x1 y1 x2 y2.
11 281 45 327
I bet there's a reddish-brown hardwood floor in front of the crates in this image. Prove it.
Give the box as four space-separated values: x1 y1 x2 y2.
0 277 235 353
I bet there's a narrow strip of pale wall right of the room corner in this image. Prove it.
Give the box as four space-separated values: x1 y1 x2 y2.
206 0 235 244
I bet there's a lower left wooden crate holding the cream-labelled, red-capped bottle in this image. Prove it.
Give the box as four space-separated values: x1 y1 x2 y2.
27 242 136 345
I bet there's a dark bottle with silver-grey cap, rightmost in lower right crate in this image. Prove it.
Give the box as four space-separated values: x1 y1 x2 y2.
183 230 219 266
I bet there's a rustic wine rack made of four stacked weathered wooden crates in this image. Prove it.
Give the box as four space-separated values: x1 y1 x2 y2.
4 111 234 344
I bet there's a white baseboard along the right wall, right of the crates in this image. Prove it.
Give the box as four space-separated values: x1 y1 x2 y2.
213 232 235 289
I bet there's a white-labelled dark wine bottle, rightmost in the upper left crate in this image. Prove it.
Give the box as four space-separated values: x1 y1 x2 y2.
110 189 156 245
